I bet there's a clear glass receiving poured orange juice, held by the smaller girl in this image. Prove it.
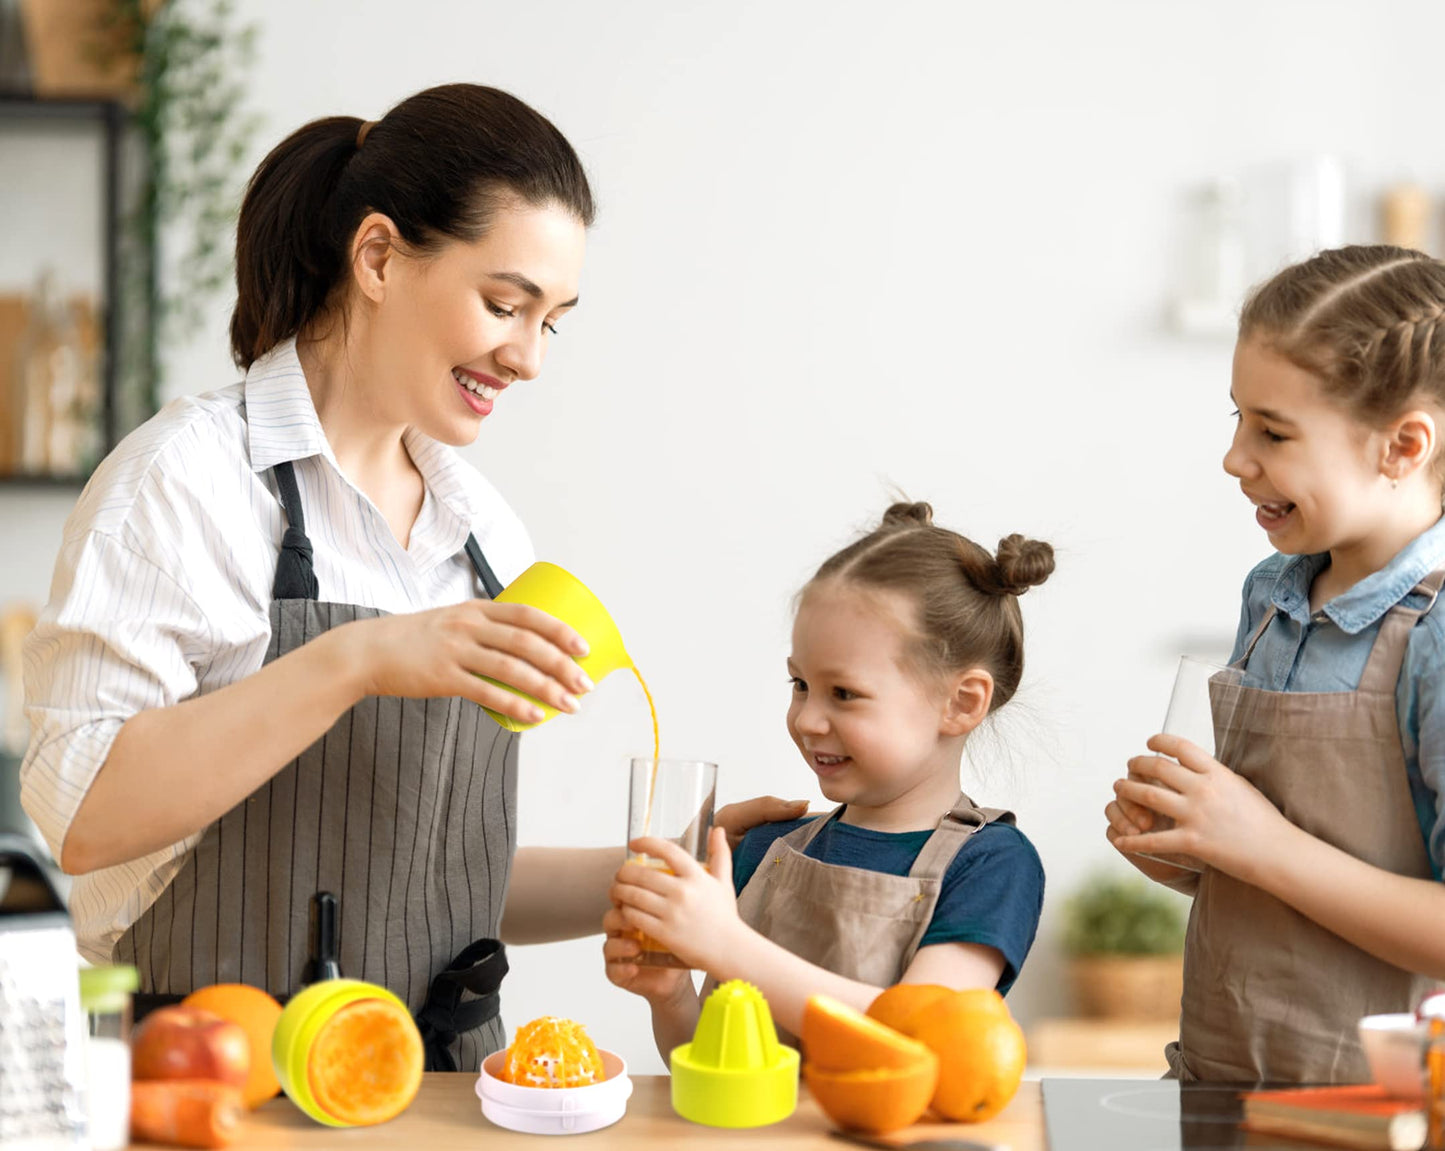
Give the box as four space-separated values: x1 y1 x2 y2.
627 758 718 968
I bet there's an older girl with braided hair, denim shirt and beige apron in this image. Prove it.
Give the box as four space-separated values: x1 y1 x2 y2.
1105 247 1445 1083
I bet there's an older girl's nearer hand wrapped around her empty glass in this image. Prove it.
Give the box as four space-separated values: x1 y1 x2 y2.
1105 734 1293 882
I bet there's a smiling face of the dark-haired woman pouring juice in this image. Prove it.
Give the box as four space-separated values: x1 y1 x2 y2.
366 201 587 445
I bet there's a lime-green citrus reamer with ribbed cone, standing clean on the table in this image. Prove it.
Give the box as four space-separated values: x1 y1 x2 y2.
670 979 798 1126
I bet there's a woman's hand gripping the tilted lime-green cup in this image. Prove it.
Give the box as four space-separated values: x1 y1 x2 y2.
334 599 592 724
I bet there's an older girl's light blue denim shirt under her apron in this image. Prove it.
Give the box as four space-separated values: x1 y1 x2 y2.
1230 518 1445 879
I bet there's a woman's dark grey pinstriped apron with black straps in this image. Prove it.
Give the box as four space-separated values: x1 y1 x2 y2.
114 462 517 1070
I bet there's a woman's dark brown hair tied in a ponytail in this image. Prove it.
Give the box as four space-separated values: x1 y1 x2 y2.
231 84 595 368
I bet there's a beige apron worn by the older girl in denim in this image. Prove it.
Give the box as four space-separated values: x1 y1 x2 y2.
1166 569 1445 1083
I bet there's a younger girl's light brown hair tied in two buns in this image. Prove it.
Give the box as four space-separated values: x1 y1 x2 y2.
801 503 1053 712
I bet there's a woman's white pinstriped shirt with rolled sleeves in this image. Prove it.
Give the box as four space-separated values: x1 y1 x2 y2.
20 341 533 963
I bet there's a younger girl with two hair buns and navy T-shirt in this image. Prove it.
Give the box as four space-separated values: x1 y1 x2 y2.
604 504 1053 1056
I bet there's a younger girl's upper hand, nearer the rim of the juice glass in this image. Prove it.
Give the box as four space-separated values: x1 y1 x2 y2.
611 828 743 972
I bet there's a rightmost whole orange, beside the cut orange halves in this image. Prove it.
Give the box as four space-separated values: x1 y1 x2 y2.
907 991 1027 1124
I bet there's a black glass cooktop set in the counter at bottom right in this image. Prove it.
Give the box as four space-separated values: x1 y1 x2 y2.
1042 1079 1319 1151
